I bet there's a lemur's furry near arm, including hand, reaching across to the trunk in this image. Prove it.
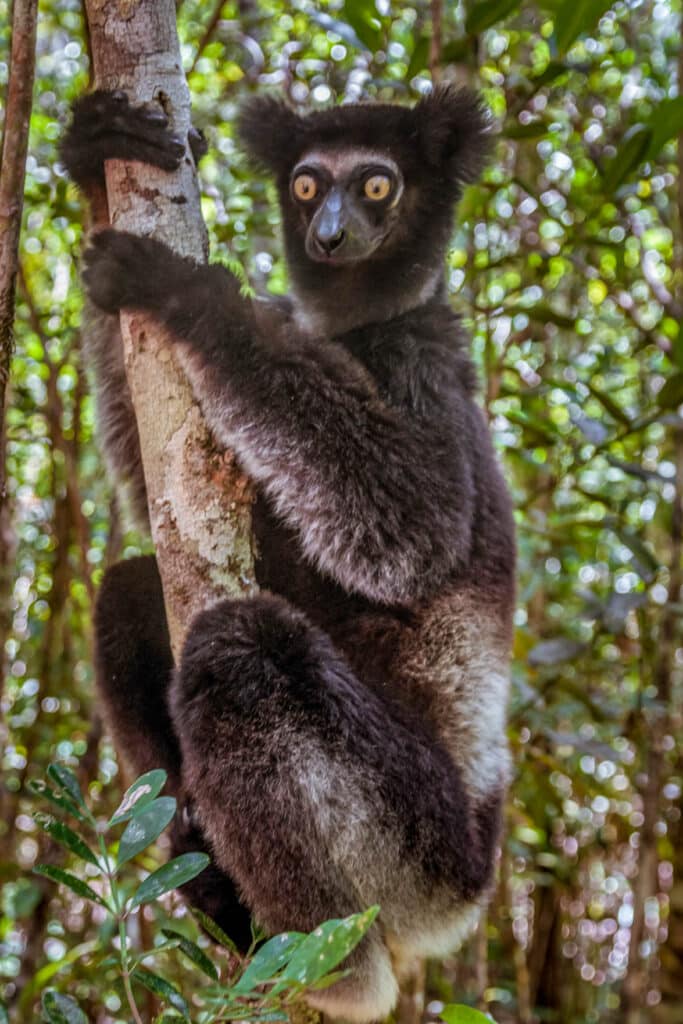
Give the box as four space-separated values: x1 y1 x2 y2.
84 230 473 603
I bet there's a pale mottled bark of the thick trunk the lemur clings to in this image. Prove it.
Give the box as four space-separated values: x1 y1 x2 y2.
86 0 255 655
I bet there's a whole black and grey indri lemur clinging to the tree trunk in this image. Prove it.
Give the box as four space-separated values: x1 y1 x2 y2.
62 87 514 1021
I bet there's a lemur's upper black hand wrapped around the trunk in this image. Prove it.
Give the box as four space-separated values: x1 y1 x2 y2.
60 89 207 186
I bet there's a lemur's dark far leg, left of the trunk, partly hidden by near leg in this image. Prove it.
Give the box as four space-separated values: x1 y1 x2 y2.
95 556 251 949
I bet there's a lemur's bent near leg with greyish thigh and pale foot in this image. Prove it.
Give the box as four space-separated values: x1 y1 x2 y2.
171 594 496 1020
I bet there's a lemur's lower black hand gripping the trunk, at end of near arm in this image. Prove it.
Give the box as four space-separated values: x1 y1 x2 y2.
82 228 187 313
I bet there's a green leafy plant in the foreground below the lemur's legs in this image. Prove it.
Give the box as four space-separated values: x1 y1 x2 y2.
31 764 379 1024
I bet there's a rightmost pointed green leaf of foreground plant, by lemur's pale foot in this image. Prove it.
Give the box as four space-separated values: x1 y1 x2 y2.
272 906 380 994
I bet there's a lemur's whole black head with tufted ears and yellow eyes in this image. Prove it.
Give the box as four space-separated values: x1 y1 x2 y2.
239 86 489 331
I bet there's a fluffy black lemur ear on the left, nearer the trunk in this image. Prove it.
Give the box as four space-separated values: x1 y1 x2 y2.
238 96 304 174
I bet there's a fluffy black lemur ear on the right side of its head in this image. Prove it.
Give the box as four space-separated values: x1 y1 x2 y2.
414 85 493 184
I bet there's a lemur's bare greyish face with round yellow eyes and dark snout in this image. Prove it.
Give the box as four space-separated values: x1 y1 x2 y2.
289 147 403 266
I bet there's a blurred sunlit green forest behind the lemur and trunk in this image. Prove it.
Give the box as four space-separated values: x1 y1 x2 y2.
0 0 683 1024
